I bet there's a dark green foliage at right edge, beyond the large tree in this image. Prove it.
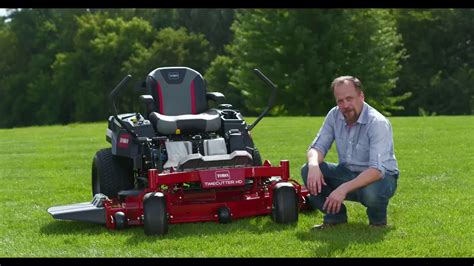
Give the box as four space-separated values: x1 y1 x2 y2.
396 9 474 115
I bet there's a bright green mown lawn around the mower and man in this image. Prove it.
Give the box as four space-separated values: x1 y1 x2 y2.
0 116 474 257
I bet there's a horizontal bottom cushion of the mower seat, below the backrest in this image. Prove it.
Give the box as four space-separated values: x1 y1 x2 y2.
150 109 221 135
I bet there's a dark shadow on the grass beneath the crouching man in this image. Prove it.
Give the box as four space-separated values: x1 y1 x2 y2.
296 218 395 257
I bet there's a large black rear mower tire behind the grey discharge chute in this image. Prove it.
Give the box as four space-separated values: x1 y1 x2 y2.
92 148 134 198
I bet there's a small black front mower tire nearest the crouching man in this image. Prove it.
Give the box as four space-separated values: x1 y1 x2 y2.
272 182 298 224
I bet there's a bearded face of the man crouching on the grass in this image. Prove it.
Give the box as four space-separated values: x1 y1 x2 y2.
334 80 364 124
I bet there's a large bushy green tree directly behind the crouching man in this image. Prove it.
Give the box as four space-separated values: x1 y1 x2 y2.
224 9 403 115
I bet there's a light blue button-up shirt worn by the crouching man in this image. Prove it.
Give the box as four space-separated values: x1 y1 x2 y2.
309 102 399 177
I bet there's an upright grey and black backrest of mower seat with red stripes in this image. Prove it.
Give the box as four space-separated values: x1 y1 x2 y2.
146 67 209 115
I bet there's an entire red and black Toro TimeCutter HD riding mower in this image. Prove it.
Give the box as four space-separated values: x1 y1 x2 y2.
48 67 309 235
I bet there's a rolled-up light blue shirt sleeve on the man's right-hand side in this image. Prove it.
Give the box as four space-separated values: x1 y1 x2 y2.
368 121 392 178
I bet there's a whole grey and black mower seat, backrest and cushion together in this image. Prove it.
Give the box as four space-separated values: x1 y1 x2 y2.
146 67 221 135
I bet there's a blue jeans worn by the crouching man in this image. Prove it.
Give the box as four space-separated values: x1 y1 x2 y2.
301 162 398 224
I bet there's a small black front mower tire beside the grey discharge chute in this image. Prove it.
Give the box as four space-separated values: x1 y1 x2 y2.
143 192 168 235
